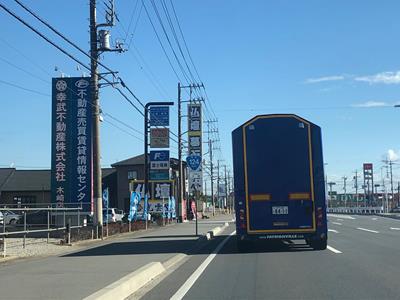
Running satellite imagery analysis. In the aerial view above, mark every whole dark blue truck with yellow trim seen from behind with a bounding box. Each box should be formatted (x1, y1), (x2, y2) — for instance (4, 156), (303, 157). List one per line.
(232, 114), (328, 250)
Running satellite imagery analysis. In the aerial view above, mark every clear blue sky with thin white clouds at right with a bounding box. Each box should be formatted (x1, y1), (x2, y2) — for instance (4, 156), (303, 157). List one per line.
(0, 0), (400, 193)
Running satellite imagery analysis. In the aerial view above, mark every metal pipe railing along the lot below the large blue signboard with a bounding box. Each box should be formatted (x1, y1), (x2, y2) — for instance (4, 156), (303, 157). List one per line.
(0, 207), (87, 257)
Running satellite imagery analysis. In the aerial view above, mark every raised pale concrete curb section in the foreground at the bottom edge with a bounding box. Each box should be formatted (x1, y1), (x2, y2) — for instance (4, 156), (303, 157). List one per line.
(84, 262), (166, 300)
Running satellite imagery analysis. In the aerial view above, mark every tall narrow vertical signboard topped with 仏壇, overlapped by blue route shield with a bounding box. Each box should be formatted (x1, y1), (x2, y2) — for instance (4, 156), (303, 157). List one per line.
(187, 104), (203, 194)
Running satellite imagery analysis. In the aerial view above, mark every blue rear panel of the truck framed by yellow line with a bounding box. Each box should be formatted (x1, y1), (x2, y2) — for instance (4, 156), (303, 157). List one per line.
(243, 115), (315, 233)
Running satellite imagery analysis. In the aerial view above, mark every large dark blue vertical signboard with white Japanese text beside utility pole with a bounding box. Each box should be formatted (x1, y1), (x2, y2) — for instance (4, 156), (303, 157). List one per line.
(51, 77), (92, 211)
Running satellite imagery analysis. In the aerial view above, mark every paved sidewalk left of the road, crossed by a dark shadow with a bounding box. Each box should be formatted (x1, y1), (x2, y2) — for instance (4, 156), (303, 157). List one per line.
(0, 215), (232, 299)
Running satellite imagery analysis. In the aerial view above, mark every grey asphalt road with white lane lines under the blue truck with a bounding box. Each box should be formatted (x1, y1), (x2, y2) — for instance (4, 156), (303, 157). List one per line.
(141, 215), (400, 299)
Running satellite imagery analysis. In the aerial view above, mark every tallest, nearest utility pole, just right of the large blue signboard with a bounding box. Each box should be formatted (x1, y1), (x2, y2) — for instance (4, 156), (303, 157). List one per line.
(89, 0), (103, 238)
